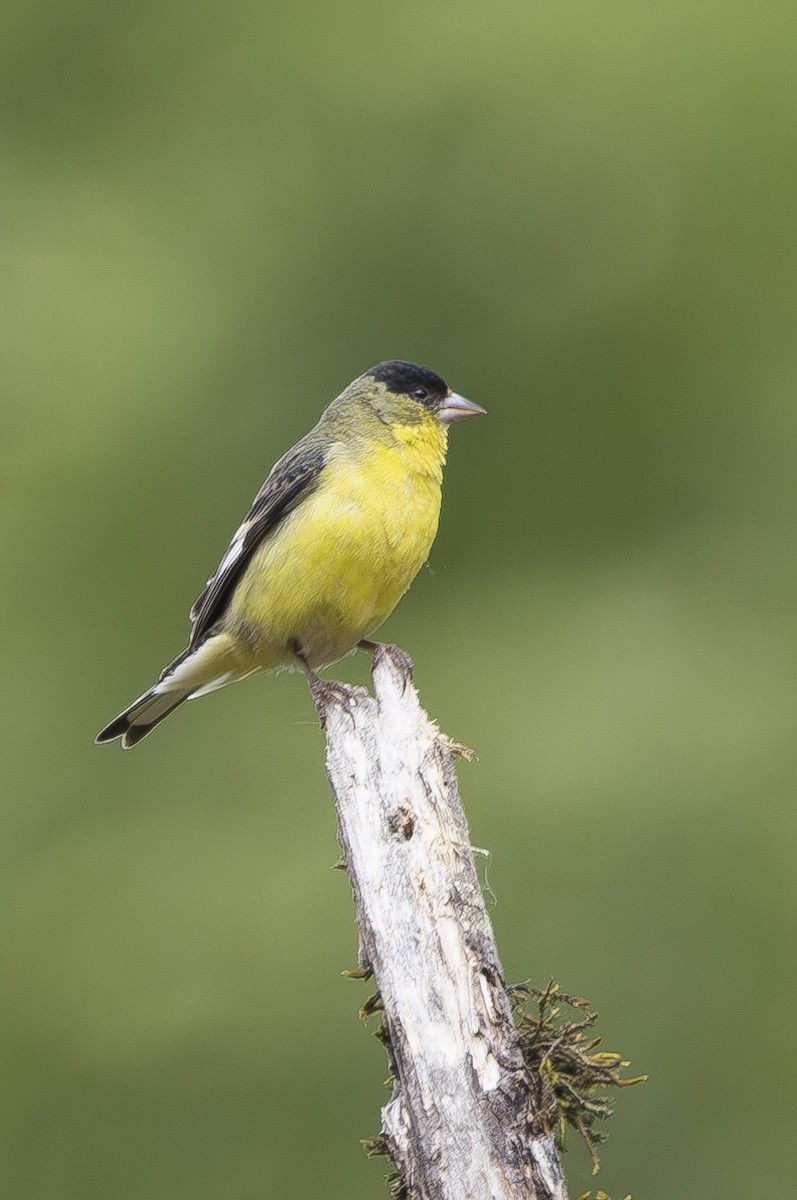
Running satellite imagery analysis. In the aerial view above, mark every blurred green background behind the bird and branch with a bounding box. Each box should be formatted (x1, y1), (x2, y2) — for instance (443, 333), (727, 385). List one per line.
(0, 0), (797, 1200)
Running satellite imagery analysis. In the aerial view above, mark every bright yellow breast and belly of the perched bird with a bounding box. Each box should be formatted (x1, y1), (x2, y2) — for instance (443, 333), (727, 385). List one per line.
(226, 421), (445, 670)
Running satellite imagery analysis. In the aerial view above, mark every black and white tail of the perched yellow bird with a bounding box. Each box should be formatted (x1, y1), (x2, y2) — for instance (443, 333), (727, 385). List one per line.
(94, 635), (245, 750)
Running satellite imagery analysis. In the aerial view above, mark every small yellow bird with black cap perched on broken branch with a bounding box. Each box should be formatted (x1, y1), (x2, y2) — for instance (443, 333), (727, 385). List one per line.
(95, 359), (485, 750)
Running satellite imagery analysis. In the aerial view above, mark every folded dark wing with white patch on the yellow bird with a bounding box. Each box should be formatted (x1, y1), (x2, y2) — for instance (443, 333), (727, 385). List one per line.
(188, 439), (329, 646)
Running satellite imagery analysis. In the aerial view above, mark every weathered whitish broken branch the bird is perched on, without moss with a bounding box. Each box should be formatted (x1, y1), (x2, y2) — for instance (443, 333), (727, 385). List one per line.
(313, 647), (567, 1200)
